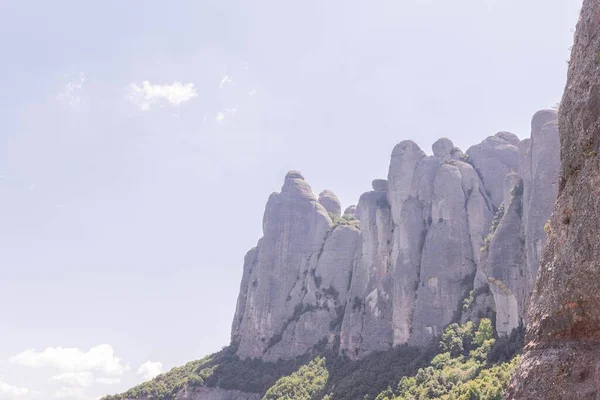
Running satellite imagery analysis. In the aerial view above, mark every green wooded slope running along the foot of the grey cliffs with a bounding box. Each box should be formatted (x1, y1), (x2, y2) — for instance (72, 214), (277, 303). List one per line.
(105, 318), (525, 400)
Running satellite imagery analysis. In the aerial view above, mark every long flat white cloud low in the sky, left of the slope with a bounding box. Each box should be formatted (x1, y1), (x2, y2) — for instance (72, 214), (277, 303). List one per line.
(10, 344), (129, 376)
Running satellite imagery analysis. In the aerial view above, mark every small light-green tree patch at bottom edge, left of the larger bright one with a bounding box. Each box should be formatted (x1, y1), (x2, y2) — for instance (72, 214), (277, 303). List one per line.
(263, 357), (329, 400)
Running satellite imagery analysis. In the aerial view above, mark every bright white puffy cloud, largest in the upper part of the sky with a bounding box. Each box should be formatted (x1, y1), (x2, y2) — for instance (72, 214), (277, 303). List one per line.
(125, 81), (198, 111)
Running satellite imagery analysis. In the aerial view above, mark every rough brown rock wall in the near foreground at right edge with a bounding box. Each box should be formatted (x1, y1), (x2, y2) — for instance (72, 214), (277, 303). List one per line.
(507, 0), (600, 399)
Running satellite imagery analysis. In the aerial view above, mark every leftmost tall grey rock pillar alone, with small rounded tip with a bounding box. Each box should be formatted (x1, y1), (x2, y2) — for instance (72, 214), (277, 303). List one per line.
(232, 172), (332, 358)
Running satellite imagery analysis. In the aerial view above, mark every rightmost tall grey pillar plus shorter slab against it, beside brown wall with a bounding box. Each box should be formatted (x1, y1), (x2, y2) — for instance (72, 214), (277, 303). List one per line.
(482, 110), (560, 334)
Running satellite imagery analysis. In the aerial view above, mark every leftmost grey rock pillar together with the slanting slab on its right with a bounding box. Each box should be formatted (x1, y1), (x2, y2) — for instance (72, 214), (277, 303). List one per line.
(232, 171), (359, 361)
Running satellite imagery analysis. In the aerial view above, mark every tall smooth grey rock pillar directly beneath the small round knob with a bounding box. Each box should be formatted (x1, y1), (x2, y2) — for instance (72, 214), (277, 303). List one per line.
(409, 161), (485, 345)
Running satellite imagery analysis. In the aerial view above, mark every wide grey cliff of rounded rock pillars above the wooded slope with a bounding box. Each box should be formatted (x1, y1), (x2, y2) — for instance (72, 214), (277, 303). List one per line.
(232, 110), (559, 361)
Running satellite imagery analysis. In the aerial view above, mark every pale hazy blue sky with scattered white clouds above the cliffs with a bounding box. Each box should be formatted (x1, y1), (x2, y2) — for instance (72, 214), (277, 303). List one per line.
(0, 0), (581, 400)
